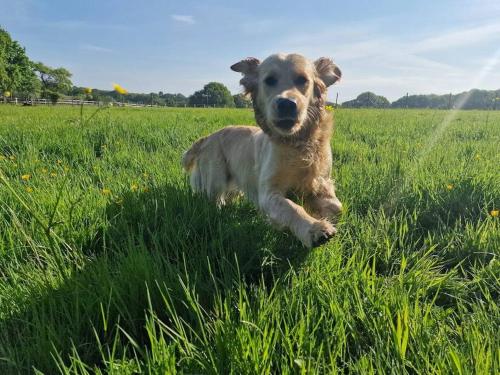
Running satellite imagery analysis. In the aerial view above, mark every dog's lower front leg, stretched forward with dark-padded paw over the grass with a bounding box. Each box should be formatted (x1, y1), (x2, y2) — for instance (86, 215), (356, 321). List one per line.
(259, 191), (337, 248)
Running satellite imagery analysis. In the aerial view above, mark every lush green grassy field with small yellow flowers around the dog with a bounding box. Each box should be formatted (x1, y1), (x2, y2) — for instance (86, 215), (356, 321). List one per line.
(0, 106), (500, 374)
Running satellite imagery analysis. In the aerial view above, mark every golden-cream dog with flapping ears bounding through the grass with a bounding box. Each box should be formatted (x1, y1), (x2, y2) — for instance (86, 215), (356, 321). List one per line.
(182, 54), (342, 248)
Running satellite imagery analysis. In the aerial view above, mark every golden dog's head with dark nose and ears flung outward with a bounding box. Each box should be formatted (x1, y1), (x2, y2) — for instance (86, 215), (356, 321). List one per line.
(231, 54), (341, 138)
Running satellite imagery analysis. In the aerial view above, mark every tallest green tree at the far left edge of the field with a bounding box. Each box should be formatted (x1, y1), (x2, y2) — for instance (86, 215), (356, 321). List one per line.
(0, 28), (40, 96)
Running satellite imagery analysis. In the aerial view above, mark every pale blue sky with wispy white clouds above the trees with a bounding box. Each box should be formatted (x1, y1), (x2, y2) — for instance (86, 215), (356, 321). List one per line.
(0, 0), (500, 101)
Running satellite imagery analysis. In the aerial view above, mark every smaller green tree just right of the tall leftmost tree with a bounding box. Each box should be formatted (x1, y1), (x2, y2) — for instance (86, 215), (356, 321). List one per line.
(33, 62), (73, 101)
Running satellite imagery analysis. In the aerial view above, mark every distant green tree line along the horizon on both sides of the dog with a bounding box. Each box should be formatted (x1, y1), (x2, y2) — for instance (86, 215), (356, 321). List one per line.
(0, 27), (500, 109)
